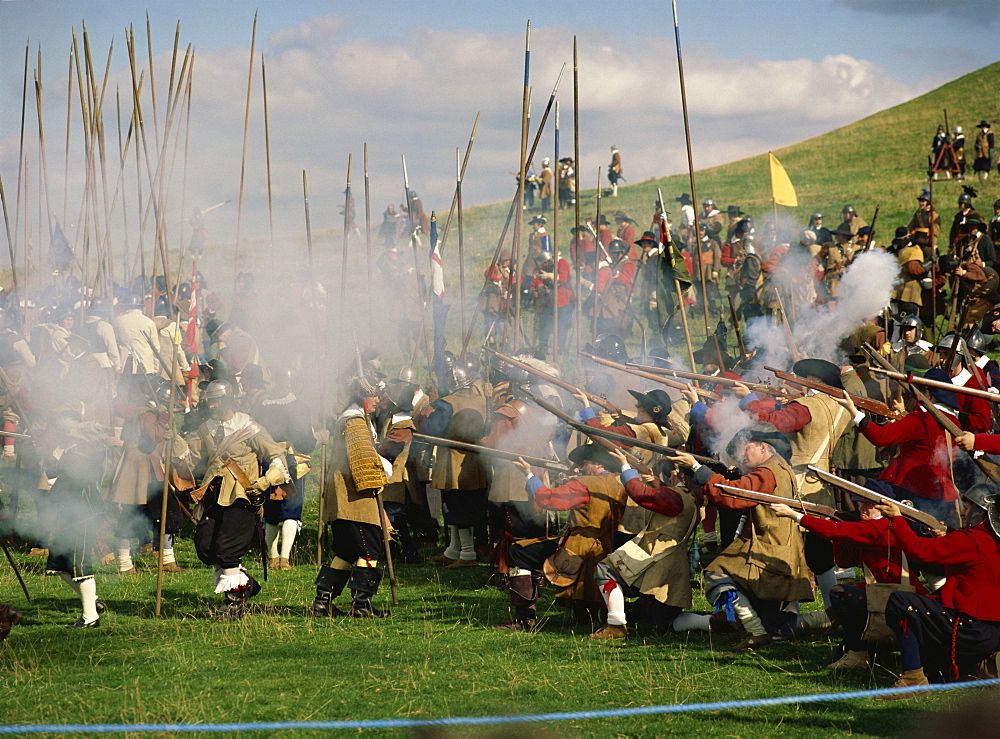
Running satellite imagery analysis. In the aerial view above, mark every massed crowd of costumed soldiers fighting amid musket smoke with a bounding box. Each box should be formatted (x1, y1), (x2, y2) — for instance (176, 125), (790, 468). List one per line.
(0, 181), (1000, 704)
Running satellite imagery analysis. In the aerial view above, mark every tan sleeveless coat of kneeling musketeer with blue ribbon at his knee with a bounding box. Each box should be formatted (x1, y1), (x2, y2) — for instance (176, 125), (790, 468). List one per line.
(705, 456), (814, 601)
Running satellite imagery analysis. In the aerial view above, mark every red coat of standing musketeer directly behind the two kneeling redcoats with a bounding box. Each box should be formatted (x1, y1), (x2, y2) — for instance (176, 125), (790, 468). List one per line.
(861, 408), (958, 501)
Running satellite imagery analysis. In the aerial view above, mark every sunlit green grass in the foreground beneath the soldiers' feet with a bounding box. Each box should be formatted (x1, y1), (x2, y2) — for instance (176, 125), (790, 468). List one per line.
(0, 482), (992, 737)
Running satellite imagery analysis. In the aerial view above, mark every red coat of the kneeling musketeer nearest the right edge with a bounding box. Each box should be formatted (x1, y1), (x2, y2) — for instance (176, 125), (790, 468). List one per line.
(892, 517), (1000, 621)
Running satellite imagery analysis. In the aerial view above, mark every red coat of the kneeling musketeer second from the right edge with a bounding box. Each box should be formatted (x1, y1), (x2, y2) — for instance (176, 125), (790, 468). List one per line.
(799, 515), (926, 595)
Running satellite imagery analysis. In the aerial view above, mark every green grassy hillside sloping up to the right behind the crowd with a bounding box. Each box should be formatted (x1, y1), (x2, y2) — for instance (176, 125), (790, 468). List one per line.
(466, 57), (1000, 251)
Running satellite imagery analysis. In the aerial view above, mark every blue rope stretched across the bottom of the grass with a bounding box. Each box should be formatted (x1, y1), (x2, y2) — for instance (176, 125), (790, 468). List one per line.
(7, 678), (1000, 734)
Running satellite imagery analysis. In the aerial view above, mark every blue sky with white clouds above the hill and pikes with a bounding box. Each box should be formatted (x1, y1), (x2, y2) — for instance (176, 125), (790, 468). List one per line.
(0, 0), (1000, 251)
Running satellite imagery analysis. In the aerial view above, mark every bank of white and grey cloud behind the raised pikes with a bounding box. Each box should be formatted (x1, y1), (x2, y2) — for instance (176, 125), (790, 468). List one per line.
(0, 16), (922, 254)
